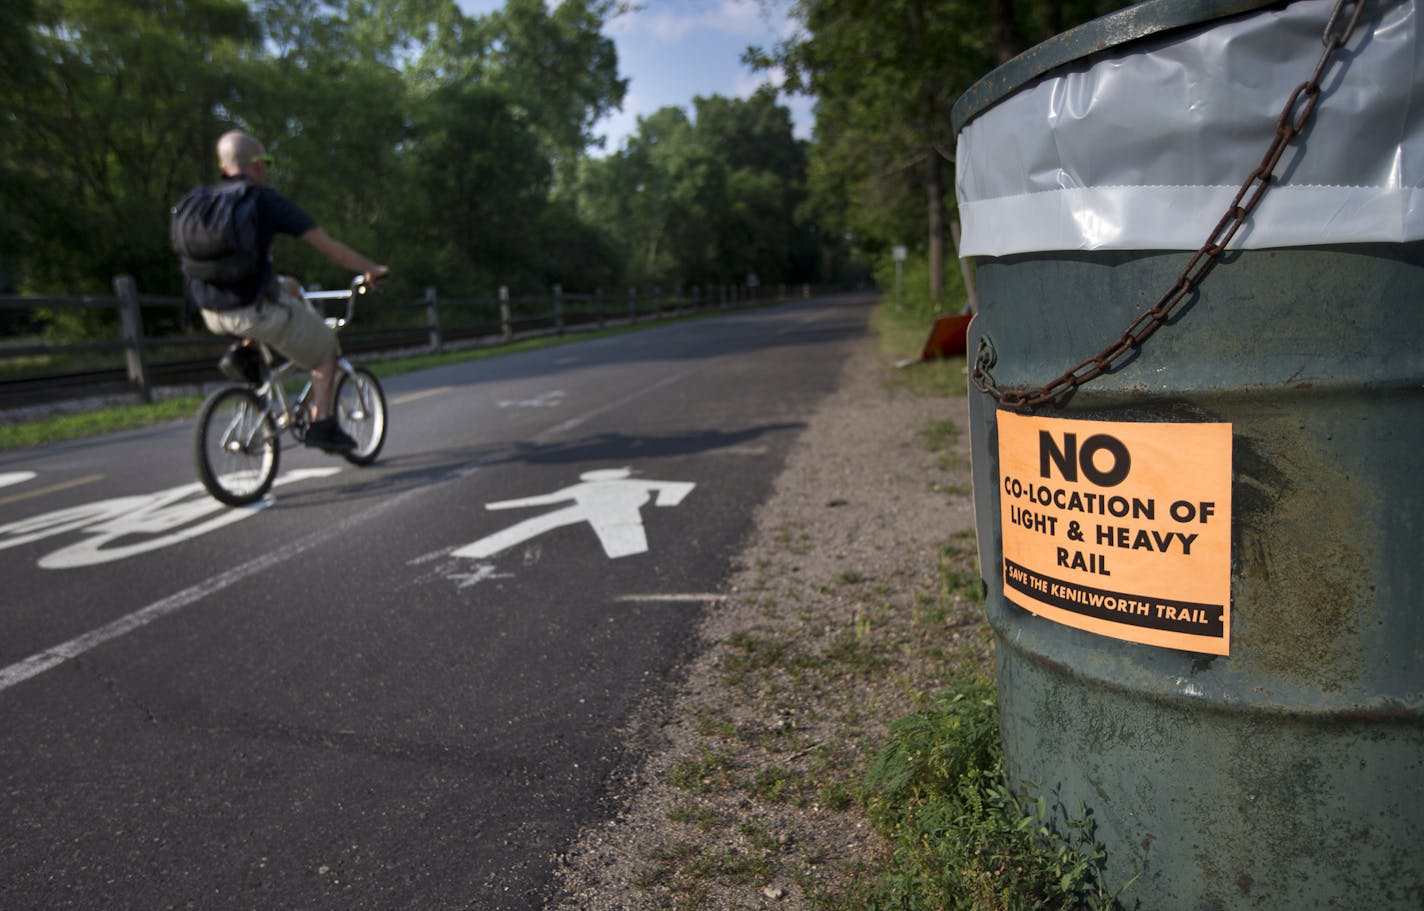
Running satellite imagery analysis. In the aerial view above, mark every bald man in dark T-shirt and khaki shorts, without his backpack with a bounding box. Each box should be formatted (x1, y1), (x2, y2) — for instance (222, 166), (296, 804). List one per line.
(184, 130), (390, 453)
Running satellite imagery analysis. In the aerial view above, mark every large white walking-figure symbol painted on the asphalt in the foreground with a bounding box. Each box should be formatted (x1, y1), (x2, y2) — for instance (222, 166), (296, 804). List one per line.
(453, 468), (696, 559)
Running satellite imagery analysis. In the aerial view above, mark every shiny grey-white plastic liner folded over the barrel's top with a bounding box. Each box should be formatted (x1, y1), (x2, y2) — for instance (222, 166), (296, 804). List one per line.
(956, 0), (1424, 256)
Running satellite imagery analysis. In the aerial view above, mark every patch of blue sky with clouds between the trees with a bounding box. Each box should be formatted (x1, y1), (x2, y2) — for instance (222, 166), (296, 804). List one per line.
(459, 0), (815, 152)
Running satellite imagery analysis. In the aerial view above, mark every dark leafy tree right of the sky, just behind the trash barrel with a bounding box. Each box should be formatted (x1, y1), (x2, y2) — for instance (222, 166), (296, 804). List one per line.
(746, 0), (1124, 306)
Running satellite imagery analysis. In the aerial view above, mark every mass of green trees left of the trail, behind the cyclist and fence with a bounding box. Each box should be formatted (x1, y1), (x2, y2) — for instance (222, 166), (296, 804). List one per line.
(0, 0), (848, 300)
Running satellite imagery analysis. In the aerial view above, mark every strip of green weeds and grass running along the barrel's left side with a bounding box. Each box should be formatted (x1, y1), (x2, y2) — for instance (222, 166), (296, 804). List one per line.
(822, 278), (1115, 911)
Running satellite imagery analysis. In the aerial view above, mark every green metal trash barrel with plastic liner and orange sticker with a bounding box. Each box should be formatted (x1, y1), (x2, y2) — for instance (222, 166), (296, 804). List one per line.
(953, 0), (1424, 911)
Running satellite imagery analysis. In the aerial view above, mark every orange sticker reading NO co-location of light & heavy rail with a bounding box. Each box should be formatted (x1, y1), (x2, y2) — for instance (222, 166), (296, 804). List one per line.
(998, 411), (1232, 655)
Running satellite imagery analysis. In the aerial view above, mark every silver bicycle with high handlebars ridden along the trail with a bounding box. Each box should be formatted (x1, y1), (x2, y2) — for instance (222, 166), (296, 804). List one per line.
(194, 276), (386, 507)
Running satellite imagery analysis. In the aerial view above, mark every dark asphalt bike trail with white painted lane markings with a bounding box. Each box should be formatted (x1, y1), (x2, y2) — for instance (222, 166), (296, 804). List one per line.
(0, 296), (869, 908)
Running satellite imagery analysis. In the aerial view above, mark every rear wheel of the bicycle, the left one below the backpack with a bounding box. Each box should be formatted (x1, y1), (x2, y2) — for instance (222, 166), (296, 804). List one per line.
(194, 386), (282, 507)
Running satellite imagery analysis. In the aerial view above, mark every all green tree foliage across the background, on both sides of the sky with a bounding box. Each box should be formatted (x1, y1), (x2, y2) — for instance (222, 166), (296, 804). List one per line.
(0, 0), (1121, 327)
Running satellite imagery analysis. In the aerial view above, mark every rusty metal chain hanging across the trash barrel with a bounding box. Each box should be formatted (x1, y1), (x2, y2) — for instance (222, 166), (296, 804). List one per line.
(971, 0), (1366, 411)
